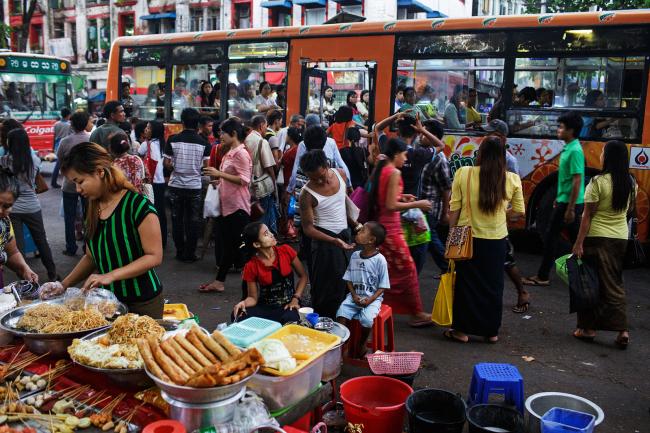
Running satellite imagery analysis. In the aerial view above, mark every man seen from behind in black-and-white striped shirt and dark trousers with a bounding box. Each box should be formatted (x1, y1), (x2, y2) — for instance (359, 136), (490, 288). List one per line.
(164, 108), (210, 263)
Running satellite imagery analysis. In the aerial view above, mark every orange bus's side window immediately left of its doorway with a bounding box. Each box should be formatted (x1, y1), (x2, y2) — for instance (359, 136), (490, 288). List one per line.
(228, 61), (287, 121)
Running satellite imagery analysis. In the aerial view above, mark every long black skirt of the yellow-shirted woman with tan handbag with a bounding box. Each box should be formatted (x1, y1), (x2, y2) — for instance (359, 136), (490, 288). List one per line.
(452, 238), (506, 337)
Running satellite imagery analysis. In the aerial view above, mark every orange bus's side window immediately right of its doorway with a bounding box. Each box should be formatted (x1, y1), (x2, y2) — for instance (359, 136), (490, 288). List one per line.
(395, 58), (504, 129)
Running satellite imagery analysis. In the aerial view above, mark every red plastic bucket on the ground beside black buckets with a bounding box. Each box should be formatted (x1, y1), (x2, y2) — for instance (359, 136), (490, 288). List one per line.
(341, 376), (413, 433)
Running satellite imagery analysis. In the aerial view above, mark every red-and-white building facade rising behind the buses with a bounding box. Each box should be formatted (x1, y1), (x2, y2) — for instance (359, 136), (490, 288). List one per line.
(3, 0), (470, 93)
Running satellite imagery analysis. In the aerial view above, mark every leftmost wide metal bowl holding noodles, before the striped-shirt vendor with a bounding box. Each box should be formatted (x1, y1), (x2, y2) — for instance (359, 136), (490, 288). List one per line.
(0, 299), (128, 356)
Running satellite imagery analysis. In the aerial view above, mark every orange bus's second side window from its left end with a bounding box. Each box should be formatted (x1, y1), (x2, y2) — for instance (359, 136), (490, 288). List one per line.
(171, 64), (221, 120)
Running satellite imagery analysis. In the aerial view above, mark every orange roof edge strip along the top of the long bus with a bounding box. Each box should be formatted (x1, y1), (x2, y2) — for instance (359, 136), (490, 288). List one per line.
(115, 9), (650, 47)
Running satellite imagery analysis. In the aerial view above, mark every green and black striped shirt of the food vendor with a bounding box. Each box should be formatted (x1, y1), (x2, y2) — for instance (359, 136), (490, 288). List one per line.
(88, 191), (162, 303)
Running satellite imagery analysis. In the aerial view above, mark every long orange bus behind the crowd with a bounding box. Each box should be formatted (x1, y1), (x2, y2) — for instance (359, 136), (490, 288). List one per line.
(107, 10), (650, 240)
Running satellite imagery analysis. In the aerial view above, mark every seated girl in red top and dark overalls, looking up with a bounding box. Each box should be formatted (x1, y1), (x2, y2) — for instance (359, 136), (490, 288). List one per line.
(233, 222), (307, 324)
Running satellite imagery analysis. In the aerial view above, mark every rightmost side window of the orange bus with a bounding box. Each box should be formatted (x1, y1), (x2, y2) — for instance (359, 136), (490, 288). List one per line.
(508, 57), (645, 139)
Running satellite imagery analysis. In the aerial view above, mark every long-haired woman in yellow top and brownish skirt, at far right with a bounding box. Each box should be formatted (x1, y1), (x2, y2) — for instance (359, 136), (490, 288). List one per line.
(573, 140), (636, 349)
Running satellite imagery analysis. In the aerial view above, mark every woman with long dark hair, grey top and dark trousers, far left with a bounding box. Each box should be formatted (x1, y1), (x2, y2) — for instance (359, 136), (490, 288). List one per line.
(0, 128), (57, 280)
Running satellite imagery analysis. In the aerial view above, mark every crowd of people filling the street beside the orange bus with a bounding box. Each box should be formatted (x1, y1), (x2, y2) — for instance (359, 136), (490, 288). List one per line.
(0, 91), (636, 356)
